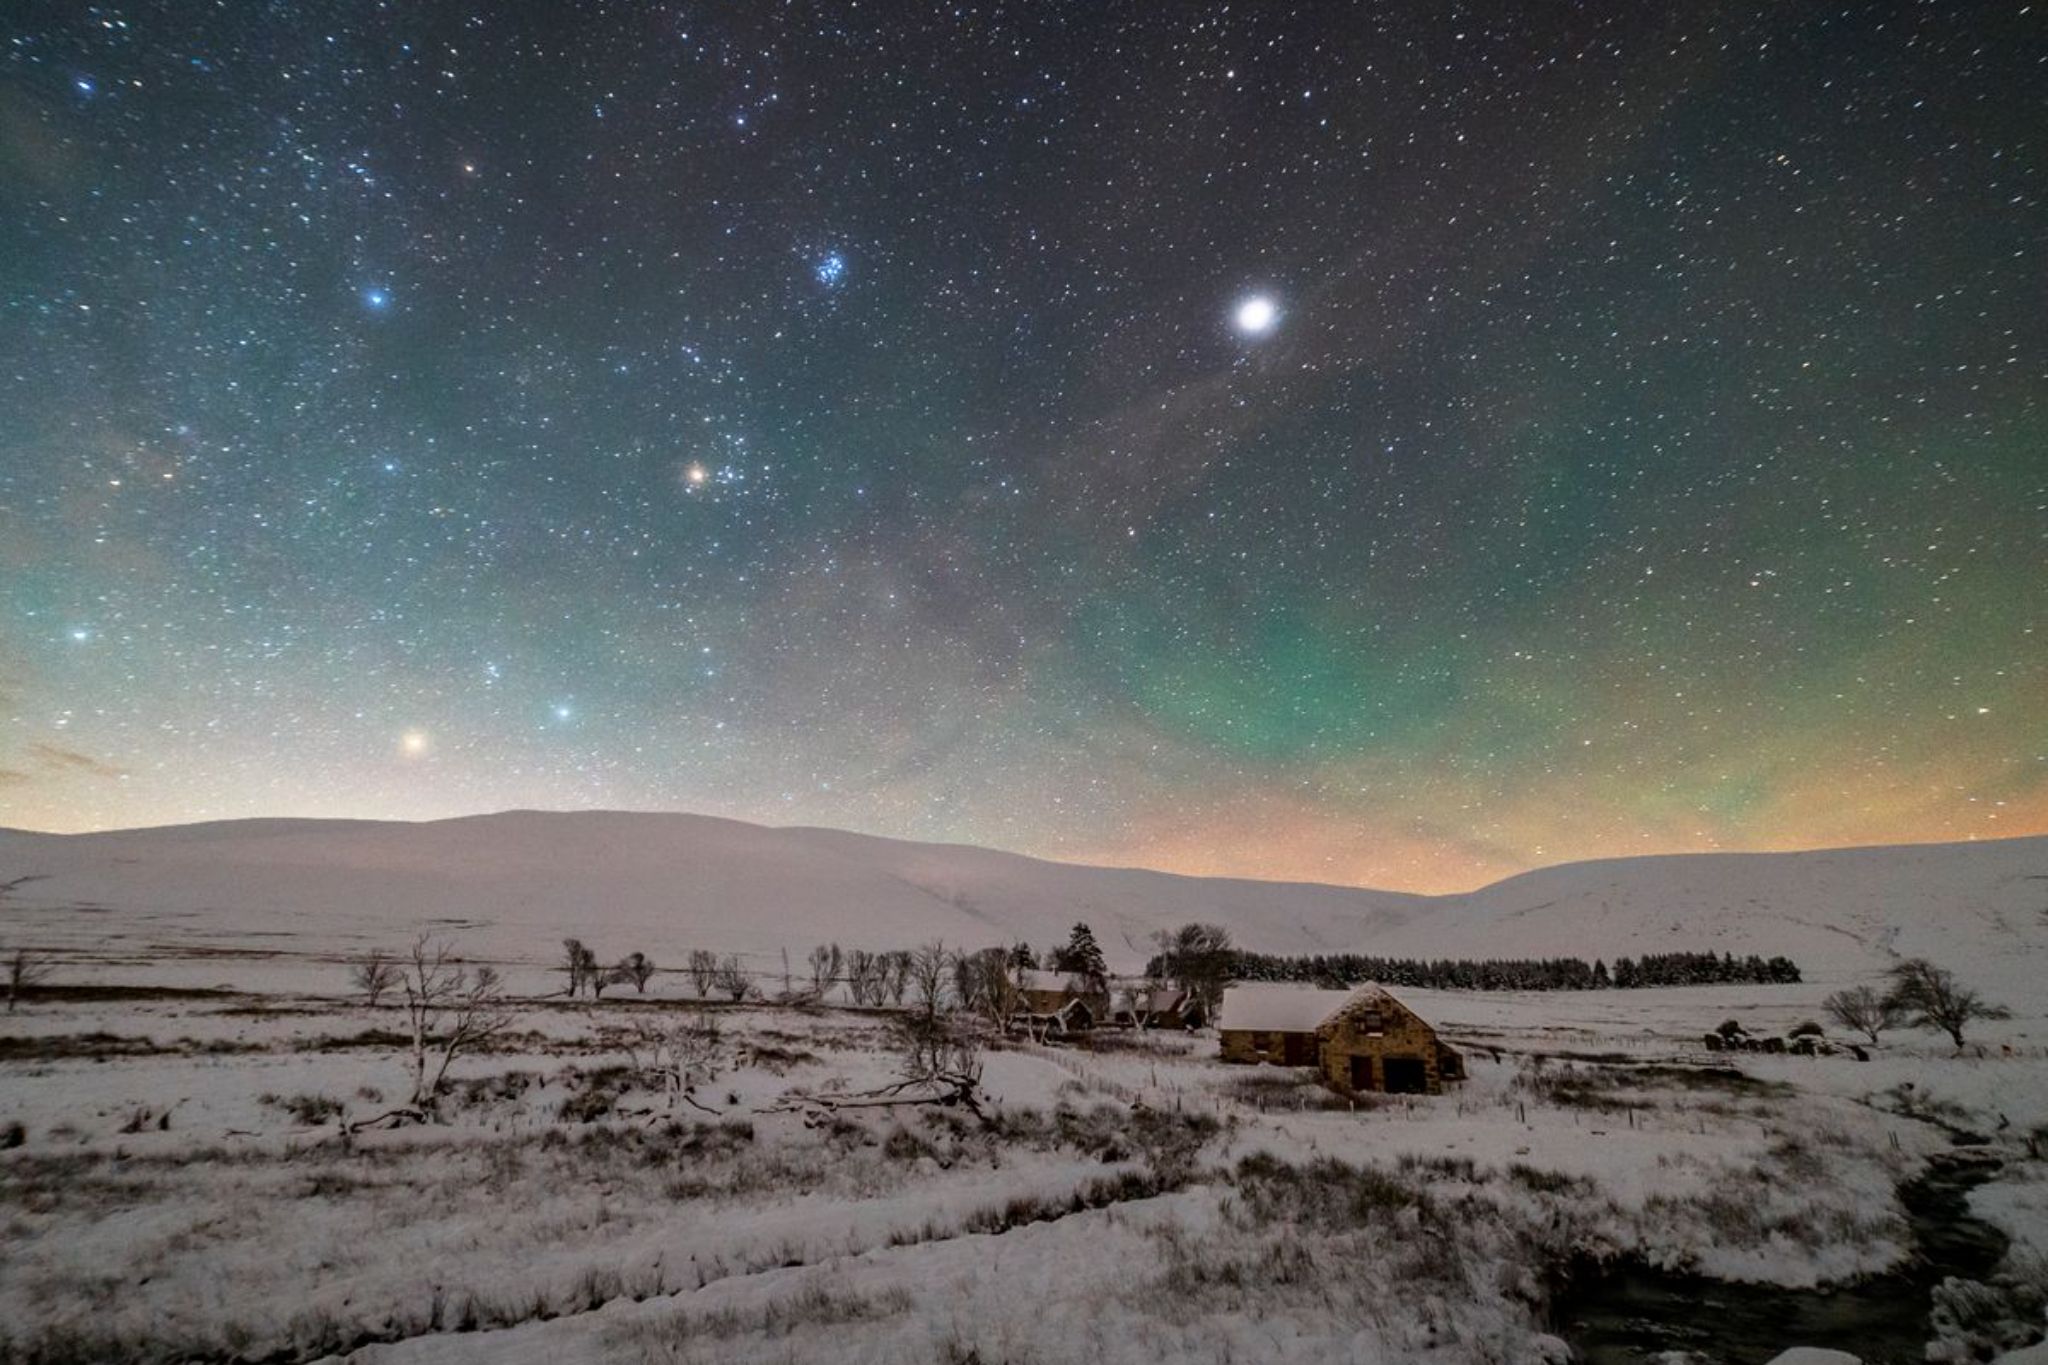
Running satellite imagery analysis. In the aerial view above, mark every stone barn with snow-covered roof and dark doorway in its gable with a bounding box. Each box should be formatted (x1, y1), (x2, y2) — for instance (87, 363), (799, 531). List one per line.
(1219, 984), (1464, 1095)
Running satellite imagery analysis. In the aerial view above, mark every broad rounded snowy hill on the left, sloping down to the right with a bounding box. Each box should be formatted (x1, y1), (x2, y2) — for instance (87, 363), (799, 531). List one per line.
(0, 810), (1430, 964)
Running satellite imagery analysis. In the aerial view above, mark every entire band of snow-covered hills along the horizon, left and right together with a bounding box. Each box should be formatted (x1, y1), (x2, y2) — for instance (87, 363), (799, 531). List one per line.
(0, 810), (2048, 995)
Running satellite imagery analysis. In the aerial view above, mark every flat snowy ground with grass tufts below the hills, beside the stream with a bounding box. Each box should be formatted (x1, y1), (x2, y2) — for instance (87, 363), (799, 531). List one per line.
(0, 962), (2048, 1365)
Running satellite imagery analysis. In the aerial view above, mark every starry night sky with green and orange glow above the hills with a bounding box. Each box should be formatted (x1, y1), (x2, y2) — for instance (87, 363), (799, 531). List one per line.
(0, 0), (2048, 890)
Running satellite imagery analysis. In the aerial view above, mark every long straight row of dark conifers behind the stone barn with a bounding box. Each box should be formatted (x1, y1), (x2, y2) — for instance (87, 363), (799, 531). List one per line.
(1196, 950), (1800, 990)
